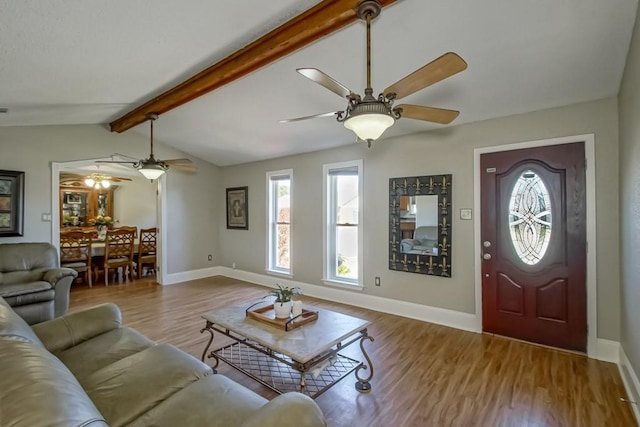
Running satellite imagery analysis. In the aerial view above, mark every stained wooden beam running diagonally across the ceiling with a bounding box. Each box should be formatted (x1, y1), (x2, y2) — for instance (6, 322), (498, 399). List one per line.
(109, 0), (397, 133)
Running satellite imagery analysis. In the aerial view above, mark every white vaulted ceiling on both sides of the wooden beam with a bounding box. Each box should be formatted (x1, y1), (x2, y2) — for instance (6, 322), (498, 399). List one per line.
(0, 0), (638, 166)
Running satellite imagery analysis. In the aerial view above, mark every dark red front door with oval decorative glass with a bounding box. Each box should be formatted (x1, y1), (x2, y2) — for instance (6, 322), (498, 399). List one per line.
(480, 143), (587, 351)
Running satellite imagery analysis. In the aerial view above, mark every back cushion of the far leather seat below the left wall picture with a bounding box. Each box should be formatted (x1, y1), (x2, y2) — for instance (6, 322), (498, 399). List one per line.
(0, 243), (59, 285)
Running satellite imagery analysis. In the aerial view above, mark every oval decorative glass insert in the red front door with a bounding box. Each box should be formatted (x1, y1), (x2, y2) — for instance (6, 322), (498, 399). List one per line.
(508, 170), (551, 265)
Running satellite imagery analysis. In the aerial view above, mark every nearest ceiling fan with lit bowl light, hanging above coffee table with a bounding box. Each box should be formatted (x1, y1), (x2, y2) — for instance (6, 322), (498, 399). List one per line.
(280, 0), (467, 147)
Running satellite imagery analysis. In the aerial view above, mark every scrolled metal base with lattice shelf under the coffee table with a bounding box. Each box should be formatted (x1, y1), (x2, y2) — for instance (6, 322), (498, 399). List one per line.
(200, 321), (373, 398)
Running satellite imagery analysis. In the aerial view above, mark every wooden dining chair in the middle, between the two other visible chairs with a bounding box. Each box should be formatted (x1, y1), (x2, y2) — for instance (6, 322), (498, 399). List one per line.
(103, 227), (138, 286)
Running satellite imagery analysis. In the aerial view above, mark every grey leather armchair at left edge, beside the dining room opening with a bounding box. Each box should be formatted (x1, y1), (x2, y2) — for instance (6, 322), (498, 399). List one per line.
(0, 243), (78, 324)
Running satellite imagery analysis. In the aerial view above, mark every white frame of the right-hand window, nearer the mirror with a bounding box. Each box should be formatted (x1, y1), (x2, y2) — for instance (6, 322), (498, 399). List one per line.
(322, 159), (364, 289)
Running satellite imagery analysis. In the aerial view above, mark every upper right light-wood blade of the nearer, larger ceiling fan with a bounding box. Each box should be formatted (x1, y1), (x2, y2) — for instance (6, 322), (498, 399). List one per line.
(383, 52), (467, 99)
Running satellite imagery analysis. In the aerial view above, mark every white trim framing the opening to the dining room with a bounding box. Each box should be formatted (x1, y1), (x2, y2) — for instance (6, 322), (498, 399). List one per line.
(51, 157), (167, 285)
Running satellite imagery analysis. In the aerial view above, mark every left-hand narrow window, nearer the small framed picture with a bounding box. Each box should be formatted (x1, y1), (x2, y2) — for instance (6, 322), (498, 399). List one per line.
(267, 169), (293, 275)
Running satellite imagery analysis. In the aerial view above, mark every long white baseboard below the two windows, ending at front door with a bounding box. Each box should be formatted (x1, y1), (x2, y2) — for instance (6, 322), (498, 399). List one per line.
(218, 267), (478, 332)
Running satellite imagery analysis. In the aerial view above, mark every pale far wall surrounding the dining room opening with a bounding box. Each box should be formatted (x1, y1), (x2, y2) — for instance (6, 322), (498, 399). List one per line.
(0, 125), (224, 273)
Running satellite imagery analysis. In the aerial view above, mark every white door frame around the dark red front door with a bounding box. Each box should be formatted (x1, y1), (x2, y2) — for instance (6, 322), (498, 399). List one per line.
(473, 133), (598, 358)
